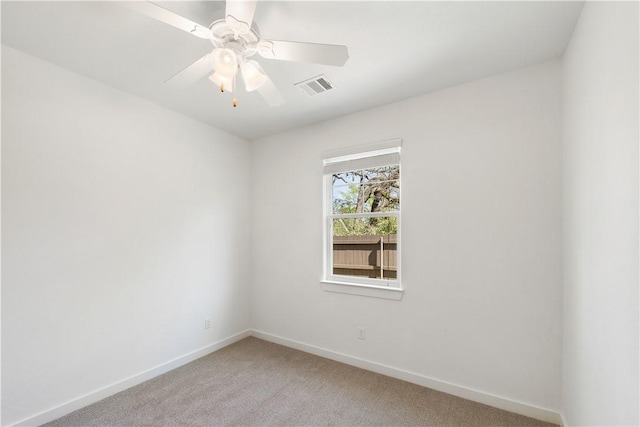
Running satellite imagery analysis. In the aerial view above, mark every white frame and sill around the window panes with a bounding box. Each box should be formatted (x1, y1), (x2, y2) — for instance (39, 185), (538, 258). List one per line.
(321, 139), (403, 300)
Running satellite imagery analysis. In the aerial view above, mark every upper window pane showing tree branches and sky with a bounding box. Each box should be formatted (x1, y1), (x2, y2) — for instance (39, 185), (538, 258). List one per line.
(332, 165), (400, 213)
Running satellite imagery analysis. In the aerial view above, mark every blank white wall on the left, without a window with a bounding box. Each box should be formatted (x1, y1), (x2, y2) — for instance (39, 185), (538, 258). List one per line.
(2, 47), (250, 425)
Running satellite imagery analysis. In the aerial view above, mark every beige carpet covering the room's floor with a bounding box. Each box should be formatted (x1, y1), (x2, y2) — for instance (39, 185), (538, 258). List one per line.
(46, 337), (552, 426)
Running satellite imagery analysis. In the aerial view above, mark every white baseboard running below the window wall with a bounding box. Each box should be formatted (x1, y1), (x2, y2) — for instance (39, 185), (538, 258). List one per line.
(251, 330), (564, 424)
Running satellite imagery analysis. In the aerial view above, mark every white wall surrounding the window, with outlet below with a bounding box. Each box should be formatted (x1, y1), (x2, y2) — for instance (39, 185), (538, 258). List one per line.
(252, 61), (562, 418)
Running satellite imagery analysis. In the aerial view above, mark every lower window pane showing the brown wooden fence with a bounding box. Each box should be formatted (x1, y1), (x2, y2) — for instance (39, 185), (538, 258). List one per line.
(332, 217), (398, 280)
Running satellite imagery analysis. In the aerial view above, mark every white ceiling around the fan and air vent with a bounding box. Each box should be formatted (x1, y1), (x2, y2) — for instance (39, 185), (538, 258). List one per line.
(1, 1), (583, 139)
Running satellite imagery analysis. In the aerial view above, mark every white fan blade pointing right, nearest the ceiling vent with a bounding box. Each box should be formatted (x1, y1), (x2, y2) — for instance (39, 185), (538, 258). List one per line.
(258, 40), (349, 66)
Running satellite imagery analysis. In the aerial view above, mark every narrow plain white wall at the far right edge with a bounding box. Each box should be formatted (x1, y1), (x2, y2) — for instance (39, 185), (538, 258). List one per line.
(563, 2), (640, 426)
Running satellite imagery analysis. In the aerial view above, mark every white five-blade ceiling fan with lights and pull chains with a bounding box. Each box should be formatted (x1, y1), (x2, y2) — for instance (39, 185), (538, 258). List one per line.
(127, 0), (349, 107)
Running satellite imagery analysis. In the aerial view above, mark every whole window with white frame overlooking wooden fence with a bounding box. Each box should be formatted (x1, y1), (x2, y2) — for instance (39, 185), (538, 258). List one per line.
(324, 140), (400, 293)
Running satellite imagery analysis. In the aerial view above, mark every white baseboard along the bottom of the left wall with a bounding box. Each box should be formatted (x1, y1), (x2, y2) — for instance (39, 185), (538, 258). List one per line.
(13, 330), (251, 426)
